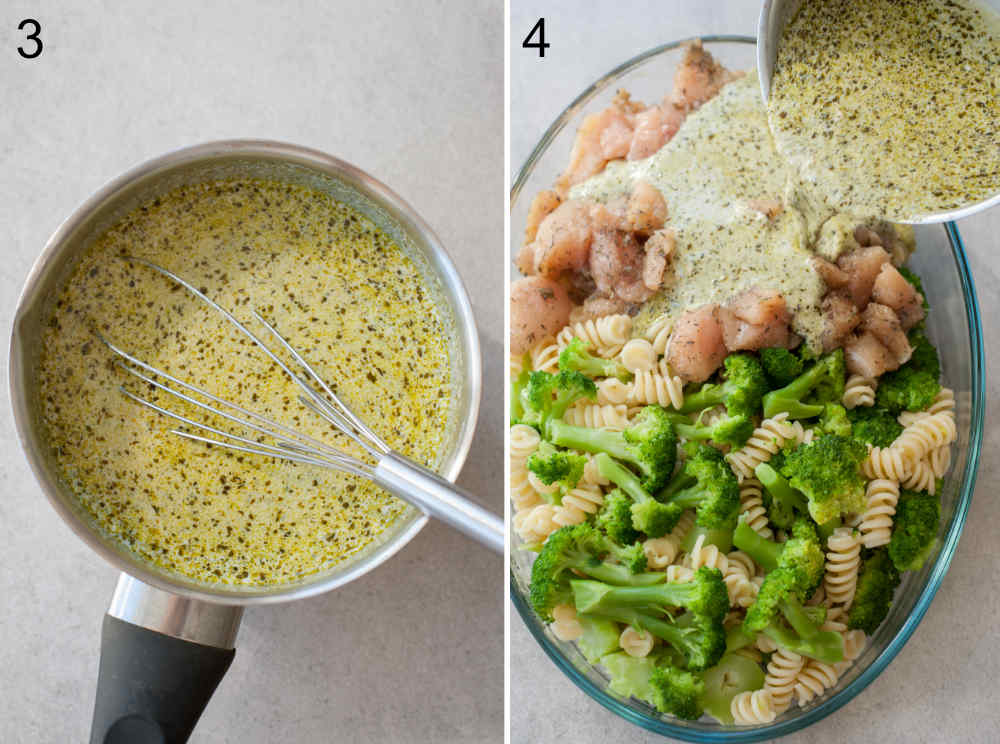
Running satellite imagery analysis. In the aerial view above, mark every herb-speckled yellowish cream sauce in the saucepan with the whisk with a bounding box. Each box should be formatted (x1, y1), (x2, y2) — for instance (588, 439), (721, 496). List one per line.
(40, 179), (452, 585)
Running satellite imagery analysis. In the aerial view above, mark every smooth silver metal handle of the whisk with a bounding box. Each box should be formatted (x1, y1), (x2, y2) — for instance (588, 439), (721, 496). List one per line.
(375, 452), (504, 553)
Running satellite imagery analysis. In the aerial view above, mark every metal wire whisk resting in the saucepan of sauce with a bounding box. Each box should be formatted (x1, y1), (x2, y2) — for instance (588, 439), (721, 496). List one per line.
(100, 256), (504, 553)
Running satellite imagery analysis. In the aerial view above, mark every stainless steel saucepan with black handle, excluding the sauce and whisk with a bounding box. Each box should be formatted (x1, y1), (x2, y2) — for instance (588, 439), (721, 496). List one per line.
(10, 140), (481, 744)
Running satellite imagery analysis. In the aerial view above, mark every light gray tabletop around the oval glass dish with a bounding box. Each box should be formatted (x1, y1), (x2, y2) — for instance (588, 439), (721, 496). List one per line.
(510, 0), (1000, 744)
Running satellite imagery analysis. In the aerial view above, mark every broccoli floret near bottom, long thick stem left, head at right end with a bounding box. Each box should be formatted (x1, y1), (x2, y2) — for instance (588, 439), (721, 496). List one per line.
(570, 566), (729, 671)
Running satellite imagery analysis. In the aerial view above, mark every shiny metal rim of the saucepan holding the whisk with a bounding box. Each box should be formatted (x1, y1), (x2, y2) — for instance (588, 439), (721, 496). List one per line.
(8, 139), (482, 606)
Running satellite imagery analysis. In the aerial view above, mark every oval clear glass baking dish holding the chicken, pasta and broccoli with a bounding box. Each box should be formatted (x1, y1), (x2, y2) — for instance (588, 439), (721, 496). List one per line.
(511, 36), (985, 742)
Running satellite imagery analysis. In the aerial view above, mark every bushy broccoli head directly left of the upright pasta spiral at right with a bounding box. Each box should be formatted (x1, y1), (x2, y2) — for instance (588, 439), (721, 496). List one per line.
(781, 434), (868, 524)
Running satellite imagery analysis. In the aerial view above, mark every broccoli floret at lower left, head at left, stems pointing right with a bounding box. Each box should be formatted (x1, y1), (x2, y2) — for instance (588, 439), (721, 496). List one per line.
(530, 523), (665, 620)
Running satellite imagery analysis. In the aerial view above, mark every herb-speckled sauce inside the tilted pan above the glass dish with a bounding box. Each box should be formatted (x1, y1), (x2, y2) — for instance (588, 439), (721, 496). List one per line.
(768, 0), (1000, 222)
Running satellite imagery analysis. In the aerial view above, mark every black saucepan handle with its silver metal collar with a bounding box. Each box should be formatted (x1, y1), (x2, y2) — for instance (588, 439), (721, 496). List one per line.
(90, 574), (243, 744)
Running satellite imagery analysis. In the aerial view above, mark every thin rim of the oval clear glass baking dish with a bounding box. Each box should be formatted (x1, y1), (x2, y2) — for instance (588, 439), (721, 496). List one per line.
(510, 34), (986, 742)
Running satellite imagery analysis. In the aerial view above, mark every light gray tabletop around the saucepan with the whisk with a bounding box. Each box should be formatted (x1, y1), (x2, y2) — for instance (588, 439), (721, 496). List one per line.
(0, 0), (504, 744)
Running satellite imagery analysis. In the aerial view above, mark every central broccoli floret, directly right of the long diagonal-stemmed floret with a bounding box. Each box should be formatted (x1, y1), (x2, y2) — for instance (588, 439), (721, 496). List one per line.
(659, 445), (740, 551)
